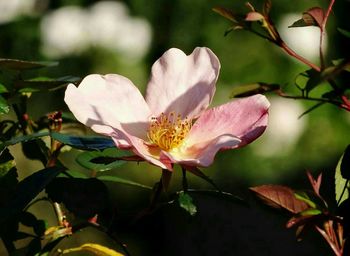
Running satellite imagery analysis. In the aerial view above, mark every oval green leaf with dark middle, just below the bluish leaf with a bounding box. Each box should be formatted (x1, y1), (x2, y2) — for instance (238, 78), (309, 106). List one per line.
(75, 147), (130, 172)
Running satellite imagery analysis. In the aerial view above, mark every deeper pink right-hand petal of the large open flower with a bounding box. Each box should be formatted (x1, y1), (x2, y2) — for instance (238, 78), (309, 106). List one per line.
(170, 95), (270, 166)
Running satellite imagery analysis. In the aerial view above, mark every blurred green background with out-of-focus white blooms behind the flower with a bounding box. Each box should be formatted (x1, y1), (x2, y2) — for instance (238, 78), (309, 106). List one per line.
(0, 0), (350, 255)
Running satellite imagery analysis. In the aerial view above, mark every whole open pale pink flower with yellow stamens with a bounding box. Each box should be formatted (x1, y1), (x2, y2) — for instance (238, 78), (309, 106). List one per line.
(65, 47), (270, 170)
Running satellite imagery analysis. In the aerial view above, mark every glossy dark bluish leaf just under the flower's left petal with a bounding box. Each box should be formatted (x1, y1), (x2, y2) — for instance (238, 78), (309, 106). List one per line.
(51, 132), (115, 150)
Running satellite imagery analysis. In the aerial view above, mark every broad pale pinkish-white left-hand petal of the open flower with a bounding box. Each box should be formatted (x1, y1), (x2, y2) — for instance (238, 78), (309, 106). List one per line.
(65, 75), (150, 142)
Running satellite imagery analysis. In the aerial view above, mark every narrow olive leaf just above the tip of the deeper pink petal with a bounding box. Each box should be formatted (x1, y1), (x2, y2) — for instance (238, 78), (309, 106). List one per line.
(230, 83), (280, 98)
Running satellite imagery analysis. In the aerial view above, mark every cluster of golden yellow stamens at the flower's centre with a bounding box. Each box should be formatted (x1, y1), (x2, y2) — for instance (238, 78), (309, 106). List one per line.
(147, 112), (192, 151)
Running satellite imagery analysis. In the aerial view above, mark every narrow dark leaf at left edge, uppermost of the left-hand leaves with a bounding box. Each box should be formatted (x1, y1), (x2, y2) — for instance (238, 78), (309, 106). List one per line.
(0, 58), (58, 70)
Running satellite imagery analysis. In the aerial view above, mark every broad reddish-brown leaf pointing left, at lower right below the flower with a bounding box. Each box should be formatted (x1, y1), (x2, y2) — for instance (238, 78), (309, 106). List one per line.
(250, 185), (309, 213)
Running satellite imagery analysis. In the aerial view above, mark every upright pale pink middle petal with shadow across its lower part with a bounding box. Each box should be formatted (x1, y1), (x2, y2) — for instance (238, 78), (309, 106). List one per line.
(146, 47), (220, 118)
